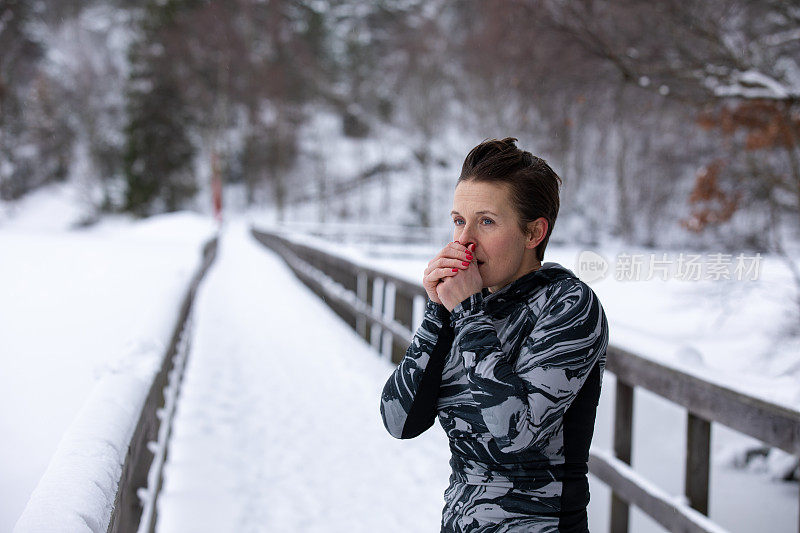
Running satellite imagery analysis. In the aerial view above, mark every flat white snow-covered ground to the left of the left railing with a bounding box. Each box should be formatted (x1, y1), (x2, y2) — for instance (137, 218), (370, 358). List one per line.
(0, 186), (215, 531)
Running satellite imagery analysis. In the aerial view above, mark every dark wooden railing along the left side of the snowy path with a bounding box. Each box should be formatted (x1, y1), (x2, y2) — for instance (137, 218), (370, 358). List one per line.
(107, 237), (217, 533)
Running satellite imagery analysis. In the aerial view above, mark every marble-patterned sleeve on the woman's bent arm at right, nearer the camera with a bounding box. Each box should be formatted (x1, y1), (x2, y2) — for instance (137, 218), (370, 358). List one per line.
(452, 279), (608, 452)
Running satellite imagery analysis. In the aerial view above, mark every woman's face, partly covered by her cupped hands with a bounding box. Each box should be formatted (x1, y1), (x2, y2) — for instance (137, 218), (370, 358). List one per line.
(451, 180), (541, 292)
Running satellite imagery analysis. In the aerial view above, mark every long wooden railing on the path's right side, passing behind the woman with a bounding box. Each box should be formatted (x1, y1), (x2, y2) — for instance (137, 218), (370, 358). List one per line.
(252, 228), (800, 533)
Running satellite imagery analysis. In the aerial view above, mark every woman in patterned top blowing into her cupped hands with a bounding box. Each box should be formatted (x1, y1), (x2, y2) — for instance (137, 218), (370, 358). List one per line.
(381, 138), (608, 532)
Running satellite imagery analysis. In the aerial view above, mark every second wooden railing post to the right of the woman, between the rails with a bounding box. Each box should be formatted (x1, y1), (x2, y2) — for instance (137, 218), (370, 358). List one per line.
(684, 411), (711, 516)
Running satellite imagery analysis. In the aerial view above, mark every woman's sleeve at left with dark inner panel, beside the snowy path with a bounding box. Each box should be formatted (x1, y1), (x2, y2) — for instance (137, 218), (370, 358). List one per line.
(381, 300), (453, 439)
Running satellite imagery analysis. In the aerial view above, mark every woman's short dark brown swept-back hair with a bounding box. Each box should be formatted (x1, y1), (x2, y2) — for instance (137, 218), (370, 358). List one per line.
(456, 137), (561, 261)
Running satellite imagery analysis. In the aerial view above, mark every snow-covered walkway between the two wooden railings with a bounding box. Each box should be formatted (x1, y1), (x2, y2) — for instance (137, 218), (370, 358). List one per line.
(157, 219), (450, 533)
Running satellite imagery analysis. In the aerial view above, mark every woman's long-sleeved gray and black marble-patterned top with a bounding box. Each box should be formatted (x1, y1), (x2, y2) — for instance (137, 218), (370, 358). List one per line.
(380, 262), (608, 531)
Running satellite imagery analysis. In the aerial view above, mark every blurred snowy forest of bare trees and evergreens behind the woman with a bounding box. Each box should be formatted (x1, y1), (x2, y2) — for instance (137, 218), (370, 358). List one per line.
(0, 0), (800, 266)
